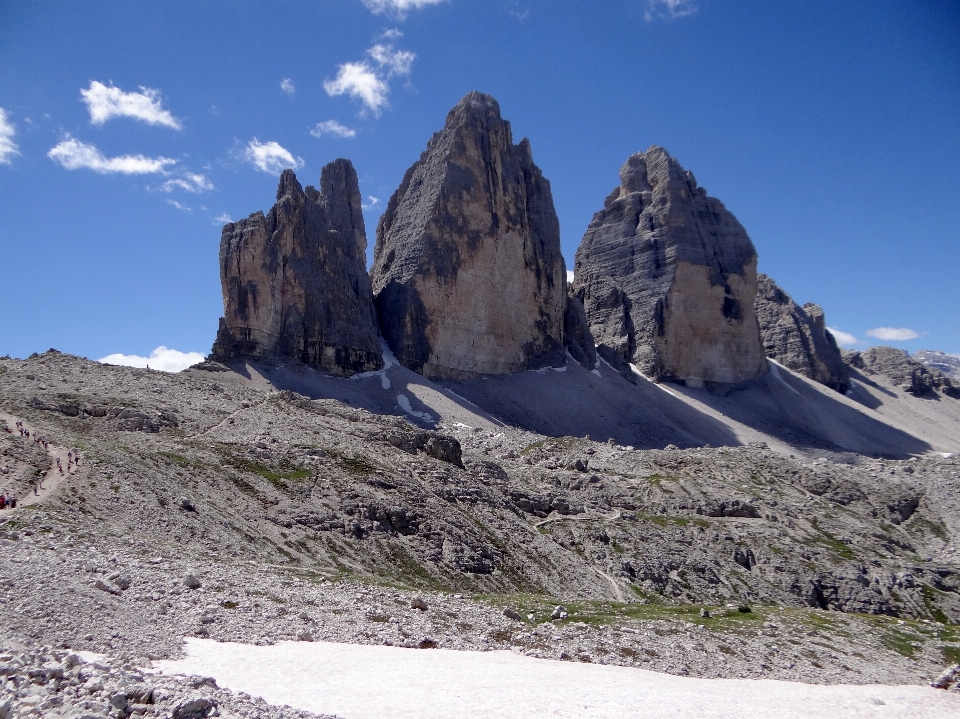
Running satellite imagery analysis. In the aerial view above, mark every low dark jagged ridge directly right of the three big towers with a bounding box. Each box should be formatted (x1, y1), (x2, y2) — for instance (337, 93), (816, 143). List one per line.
(754, 274), (850, 394)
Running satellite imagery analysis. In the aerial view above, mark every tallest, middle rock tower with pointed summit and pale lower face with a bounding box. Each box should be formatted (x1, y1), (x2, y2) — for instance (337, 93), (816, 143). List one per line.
(371, 92), (567, 379)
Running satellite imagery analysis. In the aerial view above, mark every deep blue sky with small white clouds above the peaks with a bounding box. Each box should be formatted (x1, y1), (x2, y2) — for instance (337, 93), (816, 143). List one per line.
(0, 0), (960, 368)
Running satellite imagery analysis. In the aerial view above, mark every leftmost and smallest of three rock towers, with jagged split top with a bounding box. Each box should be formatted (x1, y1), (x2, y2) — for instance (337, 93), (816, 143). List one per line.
(211, 160), (383, 375)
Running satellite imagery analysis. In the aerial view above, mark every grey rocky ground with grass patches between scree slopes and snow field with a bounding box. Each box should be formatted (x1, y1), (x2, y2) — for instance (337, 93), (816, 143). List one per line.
(0, 352), (960, 717)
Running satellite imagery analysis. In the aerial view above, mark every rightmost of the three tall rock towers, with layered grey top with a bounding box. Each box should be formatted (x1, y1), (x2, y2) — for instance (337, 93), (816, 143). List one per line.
(574, 146), (766, 386)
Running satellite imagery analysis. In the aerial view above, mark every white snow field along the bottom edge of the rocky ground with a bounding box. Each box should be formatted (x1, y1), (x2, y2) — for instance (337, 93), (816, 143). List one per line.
(153, 638), (960, 719)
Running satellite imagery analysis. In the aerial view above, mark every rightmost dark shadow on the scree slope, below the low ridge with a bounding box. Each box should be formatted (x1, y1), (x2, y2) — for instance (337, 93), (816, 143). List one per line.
(670, 362), (932, 458)
